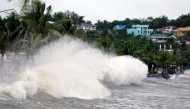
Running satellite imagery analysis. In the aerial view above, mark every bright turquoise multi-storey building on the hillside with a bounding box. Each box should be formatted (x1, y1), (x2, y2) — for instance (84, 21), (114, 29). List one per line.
(127, 25), (153, 36)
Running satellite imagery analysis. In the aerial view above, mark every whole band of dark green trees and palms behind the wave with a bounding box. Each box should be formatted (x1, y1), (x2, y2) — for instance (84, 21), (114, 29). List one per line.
(0, 0), (190, 72)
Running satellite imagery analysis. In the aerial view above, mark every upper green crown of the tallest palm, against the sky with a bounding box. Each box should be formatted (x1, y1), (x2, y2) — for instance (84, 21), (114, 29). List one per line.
(22, 0), (52, 36)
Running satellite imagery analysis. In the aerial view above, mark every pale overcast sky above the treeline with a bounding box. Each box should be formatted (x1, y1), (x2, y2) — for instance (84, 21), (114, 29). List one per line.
(0, 0), (190, 23)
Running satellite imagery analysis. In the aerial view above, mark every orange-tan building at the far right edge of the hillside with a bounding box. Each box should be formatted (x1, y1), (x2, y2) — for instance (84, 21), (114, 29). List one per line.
(173, 26), (190, 37)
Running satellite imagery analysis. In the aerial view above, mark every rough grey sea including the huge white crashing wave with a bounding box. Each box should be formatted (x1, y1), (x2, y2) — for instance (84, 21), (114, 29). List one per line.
(0, 37), (190, 109)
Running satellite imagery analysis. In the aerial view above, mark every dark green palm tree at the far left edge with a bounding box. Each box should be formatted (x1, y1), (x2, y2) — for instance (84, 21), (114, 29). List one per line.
(0, 12), (25, 61)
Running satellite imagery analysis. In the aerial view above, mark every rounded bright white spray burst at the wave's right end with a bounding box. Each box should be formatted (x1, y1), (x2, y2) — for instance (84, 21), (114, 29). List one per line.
(104, 56), (148, 85)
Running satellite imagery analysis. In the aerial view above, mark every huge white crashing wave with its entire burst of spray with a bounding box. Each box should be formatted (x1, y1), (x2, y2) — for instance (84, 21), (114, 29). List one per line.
(0, 37), (148, 99)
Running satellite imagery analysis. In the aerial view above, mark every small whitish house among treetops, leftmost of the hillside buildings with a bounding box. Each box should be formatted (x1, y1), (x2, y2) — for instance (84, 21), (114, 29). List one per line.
(77, 23), (96, 31)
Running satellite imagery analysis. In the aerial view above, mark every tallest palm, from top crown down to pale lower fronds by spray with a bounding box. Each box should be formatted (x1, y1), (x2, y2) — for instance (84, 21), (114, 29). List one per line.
(22, 0), (62, 59)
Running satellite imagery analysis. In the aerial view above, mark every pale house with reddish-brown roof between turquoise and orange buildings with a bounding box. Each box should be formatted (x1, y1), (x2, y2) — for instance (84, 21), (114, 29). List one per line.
(155, 26), (177, 34)
